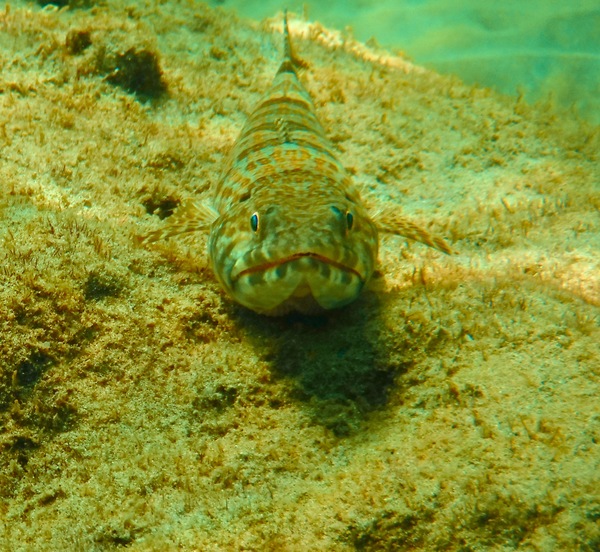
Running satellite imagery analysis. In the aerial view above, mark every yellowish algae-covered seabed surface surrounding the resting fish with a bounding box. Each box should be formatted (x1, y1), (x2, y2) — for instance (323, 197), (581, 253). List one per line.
(0, 1), (600, 552)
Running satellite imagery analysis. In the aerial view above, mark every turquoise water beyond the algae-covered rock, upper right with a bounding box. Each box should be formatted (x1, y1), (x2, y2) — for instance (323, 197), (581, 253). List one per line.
(218, 0), (600, 123)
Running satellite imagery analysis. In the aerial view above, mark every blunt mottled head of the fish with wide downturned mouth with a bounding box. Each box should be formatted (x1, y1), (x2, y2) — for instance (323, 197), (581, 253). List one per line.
(209, 194), (378, 315)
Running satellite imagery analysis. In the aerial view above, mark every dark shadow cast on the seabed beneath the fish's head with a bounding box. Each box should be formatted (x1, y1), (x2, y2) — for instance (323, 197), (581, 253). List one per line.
(240, 293), (408, 437)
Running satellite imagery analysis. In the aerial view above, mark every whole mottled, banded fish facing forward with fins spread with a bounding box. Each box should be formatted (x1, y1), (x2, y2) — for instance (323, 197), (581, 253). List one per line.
(143, 11), (449, 315)
